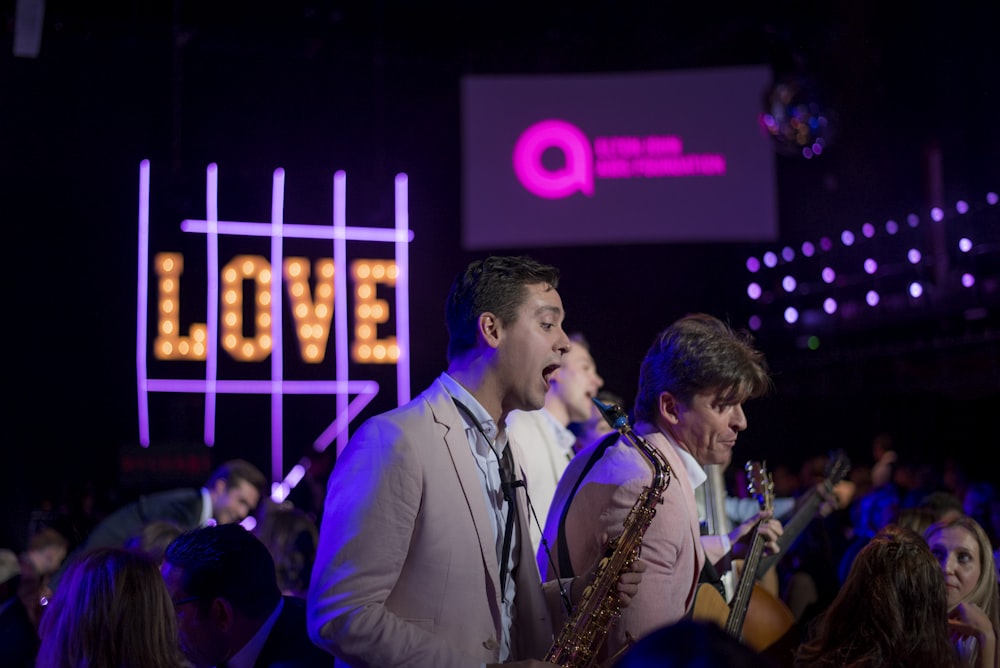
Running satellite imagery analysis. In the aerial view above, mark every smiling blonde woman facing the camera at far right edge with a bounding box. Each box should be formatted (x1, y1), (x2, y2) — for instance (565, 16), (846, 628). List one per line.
(924, 516), (1000, 668)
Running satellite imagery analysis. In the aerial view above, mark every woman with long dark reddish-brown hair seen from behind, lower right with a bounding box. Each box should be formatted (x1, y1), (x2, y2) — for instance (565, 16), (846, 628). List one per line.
(795, 525), (958, 668)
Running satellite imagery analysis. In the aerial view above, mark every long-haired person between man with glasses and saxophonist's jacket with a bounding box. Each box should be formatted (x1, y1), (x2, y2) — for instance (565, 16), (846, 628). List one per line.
(254, 499), (319, 599)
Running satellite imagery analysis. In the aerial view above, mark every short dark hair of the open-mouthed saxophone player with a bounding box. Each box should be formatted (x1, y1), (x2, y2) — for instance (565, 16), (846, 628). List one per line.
(445, 255), (559, 360)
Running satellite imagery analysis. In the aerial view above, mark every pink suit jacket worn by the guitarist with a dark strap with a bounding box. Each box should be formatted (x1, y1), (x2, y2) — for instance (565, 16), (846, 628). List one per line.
(537, 423), (725, 653)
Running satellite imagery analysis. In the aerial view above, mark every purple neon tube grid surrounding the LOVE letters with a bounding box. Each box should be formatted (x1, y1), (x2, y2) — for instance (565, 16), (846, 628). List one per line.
(136, 160), (413, 494)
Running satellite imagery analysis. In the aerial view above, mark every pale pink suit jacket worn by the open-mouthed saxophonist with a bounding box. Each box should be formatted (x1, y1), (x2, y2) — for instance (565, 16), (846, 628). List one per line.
(307, 380), (562, 668)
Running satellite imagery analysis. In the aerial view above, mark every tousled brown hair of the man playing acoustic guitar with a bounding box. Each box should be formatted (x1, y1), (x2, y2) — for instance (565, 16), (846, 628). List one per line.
(635, 313), (771, 422)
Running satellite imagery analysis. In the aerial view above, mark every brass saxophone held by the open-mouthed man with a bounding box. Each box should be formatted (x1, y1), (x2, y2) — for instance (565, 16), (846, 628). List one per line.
(545, 399), (672, 668)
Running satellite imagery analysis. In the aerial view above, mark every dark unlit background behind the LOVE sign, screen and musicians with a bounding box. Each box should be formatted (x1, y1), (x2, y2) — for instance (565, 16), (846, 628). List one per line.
(0, 0), (1000, 547)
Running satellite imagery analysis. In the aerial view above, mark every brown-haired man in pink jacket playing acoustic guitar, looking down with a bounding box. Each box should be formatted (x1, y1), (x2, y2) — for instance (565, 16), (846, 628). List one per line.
(539, 314), (782, 655)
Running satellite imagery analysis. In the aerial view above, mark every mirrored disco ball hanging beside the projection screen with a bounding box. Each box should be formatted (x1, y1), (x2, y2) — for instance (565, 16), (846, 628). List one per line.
(760, 77), (836, 159)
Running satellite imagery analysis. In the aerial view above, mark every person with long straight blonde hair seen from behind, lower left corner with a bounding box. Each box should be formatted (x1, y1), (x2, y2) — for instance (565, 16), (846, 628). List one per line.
(38, 547), (184, 668)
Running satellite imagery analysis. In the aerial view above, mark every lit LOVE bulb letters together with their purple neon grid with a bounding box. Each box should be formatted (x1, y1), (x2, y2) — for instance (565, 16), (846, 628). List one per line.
(136, 160), (413, 500)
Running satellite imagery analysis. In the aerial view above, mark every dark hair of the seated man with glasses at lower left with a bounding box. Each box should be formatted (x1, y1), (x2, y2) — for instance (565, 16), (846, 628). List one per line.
(164, 524), (281, 619)
